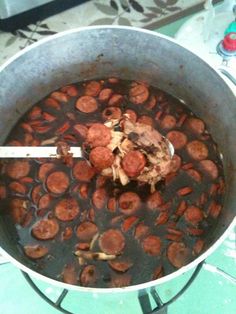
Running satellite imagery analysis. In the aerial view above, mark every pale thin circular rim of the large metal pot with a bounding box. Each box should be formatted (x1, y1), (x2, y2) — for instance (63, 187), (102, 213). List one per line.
(0, 25), (236, 293)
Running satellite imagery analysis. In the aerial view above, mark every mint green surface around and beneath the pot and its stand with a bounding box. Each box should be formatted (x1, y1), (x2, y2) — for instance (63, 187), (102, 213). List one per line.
(0, 8), (236, 314)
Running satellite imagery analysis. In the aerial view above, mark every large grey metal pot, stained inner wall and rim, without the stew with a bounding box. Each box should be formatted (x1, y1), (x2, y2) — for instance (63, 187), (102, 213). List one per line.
(0, 26), (236, 292)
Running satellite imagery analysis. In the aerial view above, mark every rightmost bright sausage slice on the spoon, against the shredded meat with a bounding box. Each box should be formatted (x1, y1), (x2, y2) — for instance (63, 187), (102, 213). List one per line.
(121, 150), (146, 177)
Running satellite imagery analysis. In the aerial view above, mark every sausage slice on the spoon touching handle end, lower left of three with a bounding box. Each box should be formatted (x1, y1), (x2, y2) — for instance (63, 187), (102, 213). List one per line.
(89, 147), (115, 170)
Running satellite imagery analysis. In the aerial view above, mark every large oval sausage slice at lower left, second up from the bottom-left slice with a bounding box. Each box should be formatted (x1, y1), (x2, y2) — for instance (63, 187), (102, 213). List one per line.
(32, 219), (59, 240)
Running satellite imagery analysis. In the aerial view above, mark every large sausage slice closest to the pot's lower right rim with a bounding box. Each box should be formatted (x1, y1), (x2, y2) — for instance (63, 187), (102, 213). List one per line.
(167, 242), (191, 268)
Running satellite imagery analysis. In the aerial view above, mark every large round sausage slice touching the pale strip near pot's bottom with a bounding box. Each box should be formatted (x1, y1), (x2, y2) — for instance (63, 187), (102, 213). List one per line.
(99, 229), (125, 255)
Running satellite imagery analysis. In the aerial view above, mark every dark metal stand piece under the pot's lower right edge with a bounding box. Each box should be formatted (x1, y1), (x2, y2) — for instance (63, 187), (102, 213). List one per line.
(138, 261), (204, 314)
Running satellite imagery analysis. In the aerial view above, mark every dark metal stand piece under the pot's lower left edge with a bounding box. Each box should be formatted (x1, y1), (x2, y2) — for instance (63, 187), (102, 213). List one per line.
(21, 271), (71, 314)
